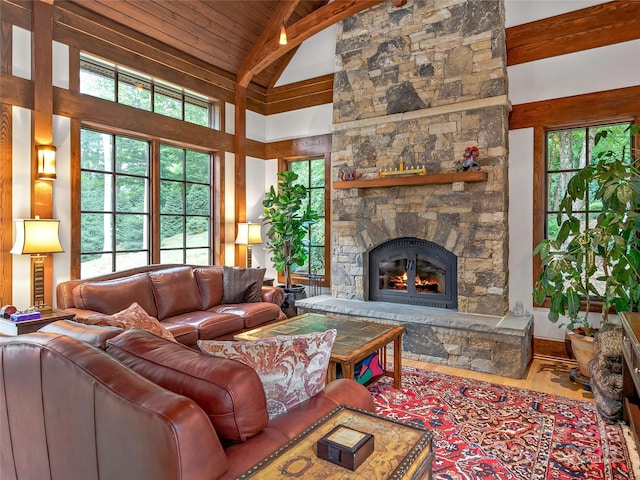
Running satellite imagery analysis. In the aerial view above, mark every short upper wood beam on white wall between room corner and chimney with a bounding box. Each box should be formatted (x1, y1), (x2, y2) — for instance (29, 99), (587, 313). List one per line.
(267, 74), (333, 115)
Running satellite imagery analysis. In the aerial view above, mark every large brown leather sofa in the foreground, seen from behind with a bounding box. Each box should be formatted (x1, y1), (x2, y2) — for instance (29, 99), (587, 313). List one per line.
(0, 321), (374, 480)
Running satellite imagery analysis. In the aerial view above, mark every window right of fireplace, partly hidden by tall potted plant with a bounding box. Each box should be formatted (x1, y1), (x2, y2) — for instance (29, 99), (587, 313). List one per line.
(545, 123), (632, 244)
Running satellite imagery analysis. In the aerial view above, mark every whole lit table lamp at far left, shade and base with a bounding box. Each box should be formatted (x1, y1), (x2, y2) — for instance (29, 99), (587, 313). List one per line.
(11, 216), (64, 311)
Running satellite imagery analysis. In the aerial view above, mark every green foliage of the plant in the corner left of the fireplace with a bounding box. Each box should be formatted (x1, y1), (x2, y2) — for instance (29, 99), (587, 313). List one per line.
(262, 170), (318, 288)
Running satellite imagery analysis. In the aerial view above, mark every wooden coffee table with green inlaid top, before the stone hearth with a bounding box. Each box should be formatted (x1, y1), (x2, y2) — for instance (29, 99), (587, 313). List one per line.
(233, 313), (405, 388)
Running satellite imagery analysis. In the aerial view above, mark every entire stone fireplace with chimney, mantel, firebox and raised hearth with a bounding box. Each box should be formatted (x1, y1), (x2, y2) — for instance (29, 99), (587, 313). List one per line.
(296, 0), (533, 378)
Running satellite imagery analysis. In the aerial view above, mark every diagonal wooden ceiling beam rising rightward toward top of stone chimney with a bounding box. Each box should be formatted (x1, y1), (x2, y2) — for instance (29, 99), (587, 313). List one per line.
(238, 0), (385, 87)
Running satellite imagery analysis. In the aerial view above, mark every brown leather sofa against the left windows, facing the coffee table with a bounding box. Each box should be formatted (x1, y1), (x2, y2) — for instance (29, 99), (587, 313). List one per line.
(56, 265), (286, 346)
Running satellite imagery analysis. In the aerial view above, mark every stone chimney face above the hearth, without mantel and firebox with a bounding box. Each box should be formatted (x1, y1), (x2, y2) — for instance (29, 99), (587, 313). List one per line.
(331, 0), (509, 316)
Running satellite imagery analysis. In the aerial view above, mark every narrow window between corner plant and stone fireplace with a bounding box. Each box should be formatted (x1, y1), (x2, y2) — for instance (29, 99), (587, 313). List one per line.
(288, 157), (329, 284)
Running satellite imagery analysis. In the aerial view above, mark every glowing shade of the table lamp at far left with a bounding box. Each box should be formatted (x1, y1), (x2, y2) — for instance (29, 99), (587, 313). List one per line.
(11, 218), (64, 255)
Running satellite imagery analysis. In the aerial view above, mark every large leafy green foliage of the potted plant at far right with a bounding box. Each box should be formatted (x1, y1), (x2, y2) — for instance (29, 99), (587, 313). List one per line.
(533, 125), (640, 336)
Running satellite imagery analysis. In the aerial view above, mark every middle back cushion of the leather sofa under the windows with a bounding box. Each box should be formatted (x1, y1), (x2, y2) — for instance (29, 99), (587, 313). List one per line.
(149, 266), (202, 320)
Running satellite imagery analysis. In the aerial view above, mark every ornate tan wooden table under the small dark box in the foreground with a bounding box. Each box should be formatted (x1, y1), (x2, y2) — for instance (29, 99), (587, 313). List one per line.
(238, 406), (434, 480)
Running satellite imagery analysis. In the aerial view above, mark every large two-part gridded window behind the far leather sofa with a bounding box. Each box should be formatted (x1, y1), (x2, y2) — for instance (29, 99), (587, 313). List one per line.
(80, 128), (212, 278)
